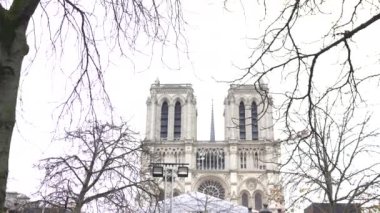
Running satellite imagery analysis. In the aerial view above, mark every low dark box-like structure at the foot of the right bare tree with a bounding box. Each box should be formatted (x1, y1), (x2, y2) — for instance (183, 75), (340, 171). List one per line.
(304, 203), (361, 213)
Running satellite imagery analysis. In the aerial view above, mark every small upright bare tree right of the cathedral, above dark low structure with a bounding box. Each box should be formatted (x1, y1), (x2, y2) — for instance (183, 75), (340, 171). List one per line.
(281, 100), (380, 212)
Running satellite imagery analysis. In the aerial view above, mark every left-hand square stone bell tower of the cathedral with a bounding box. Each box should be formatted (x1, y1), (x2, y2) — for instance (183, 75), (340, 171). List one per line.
(146, 81), (197, 141)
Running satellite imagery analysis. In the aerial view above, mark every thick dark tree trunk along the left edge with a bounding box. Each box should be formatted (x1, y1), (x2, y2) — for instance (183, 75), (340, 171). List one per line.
(0, 20), (28, 212)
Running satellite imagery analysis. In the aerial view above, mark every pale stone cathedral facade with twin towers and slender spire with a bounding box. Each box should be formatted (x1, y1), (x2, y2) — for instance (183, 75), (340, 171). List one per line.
(142, 81), (283, 210)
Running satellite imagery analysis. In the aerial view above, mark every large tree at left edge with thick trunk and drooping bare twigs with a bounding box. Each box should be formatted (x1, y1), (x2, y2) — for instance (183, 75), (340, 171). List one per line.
(0, 0), (183, 208)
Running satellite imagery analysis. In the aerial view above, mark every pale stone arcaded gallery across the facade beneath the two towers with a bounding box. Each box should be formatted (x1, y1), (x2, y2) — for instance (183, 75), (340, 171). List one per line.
(147, 140), (270, 172)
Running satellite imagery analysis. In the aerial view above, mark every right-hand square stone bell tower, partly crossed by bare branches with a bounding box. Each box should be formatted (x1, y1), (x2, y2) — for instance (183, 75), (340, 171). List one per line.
(224, 85), (273, 141)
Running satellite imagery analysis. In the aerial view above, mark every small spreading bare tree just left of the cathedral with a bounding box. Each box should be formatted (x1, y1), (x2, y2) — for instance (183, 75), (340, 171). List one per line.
(38, 122), (158, 213)
